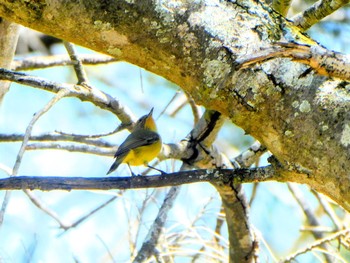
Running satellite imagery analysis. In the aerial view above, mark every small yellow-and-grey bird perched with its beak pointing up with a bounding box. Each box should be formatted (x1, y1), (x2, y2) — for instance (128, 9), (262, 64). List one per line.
(107, 108), (164, 176)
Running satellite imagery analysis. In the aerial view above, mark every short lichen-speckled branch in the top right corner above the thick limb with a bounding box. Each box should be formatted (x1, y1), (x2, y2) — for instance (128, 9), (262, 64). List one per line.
(292, 0), (349, 31)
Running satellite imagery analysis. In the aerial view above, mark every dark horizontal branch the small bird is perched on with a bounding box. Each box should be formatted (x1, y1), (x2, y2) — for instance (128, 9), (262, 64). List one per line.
(0, 166), (281, 191)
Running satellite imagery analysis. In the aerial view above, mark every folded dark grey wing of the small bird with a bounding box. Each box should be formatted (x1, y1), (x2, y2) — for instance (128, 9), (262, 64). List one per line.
(114, 129), (160, 157)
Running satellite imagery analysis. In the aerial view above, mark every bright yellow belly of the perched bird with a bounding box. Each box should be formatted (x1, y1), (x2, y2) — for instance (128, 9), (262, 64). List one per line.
(123, 140), (162, 166)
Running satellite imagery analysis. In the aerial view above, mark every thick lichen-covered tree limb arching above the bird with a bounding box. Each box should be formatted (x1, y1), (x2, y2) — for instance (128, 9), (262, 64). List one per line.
(0, 0), (350, 219)
